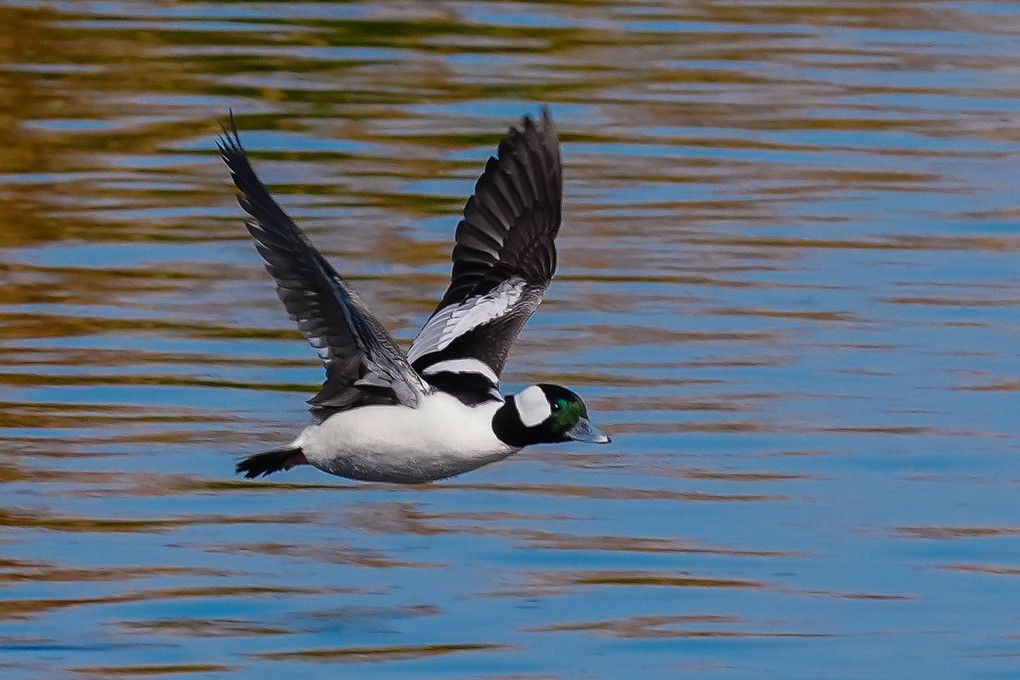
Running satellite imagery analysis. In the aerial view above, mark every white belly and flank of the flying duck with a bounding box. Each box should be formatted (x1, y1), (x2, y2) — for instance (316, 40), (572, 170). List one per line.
(295, 393), (518, 483)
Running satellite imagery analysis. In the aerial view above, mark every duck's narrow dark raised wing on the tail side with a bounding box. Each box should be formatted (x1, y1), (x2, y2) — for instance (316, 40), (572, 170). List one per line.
(218, 116), (431, 411)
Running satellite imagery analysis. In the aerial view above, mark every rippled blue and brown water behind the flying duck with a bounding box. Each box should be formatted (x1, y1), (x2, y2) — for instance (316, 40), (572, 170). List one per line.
(0, 0), (1020, 679)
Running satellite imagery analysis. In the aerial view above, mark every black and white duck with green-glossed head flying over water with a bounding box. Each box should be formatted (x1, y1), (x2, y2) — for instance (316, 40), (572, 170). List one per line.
(218, 109), (609, 483)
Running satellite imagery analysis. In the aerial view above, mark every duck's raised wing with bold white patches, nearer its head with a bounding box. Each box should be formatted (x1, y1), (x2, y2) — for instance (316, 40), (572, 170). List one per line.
(408, 109), (563, 396)
